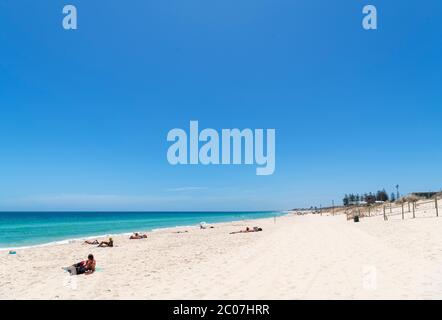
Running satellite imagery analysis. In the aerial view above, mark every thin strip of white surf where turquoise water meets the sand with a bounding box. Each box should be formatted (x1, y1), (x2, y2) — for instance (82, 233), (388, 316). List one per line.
(0, 210), (292, 253)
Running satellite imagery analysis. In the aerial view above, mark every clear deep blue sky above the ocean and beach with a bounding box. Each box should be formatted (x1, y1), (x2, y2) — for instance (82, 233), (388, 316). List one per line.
(0, 0), (442, 210)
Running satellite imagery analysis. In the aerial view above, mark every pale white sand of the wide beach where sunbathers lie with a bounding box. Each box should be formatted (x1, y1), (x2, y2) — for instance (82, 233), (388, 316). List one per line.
(0, 208), (442, 299)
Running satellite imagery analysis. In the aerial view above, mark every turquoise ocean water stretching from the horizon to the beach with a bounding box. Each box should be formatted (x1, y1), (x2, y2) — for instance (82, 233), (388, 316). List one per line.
(0, 211), (284, 249)
